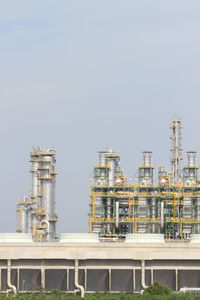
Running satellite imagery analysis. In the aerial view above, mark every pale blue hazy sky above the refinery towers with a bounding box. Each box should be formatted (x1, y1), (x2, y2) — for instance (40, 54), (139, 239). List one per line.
(0, 0), (200, 232)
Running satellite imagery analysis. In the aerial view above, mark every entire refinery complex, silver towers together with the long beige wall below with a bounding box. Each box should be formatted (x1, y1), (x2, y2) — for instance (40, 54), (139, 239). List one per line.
(0, 117), (200, 297)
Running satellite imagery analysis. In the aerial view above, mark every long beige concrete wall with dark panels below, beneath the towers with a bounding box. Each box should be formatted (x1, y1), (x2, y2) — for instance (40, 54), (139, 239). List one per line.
(0, 242), (200, 293)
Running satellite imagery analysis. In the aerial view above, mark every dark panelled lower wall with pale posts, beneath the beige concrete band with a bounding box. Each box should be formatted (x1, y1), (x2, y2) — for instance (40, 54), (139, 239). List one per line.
(0, 259), (200, 293)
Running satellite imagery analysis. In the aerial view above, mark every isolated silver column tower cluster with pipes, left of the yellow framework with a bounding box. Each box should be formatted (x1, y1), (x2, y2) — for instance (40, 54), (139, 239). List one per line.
(16, 147), (57, 241)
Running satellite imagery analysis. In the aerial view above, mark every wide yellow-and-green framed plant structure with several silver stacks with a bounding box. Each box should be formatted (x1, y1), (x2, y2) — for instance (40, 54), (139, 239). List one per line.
(89, 118), (200, 240)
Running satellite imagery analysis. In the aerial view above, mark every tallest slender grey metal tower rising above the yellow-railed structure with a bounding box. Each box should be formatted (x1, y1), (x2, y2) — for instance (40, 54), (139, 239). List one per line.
(170, 117), (183, 183)
